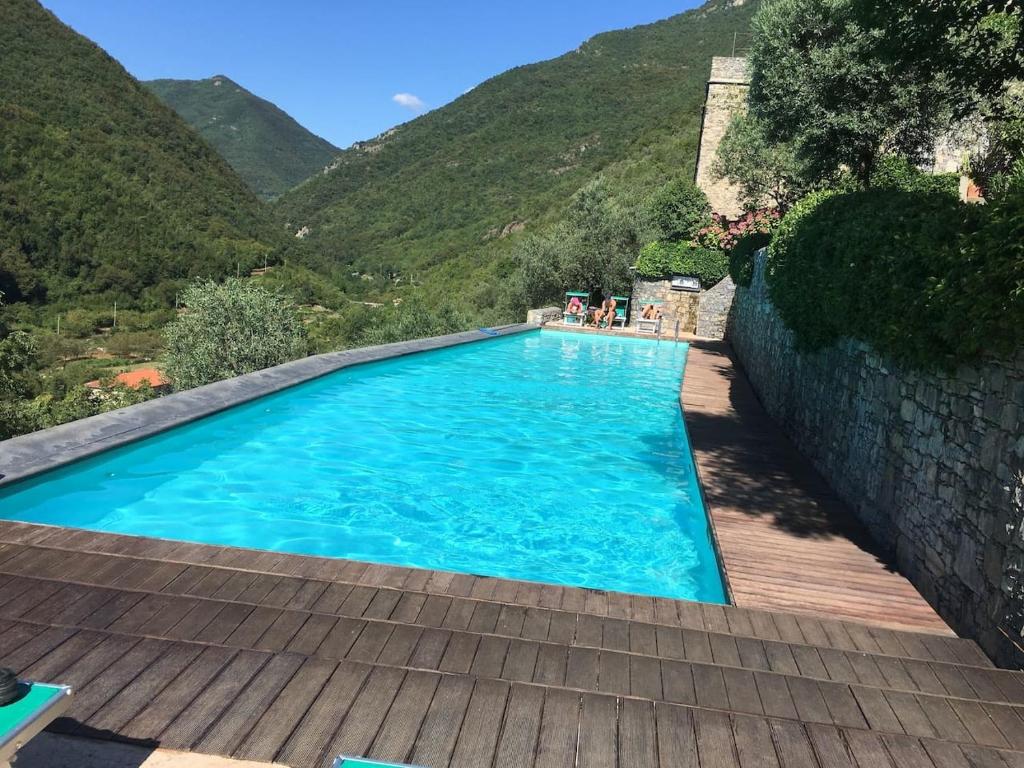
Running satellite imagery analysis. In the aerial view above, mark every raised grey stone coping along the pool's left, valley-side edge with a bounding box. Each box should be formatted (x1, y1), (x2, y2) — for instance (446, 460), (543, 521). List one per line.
(0, 323), (541, 487)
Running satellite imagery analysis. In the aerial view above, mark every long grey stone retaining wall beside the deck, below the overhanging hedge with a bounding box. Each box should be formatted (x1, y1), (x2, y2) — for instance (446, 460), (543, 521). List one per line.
(728, 253), (1024, 667)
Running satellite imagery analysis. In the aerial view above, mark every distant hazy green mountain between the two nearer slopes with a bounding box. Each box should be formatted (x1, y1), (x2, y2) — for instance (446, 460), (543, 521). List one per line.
(143, 75), (339, 200)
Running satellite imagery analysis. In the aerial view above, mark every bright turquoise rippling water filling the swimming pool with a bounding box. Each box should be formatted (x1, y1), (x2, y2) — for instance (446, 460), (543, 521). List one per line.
(0, 331), (725, 602)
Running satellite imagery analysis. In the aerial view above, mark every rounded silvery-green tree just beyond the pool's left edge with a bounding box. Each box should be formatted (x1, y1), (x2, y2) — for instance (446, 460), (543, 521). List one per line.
(165, 279), (306, 389)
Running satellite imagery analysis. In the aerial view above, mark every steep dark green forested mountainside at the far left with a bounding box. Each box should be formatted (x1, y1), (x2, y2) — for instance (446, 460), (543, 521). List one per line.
(0, 0), (286, 306)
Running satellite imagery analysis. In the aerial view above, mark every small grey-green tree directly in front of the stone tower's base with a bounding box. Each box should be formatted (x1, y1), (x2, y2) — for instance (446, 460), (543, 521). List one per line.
(712, 114), (811, 211)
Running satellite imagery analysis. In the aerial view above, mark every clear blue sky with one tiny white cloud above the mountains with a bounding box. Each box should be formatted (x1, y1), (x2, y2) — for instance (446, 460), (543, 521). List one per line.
(42, 0), (700, 147)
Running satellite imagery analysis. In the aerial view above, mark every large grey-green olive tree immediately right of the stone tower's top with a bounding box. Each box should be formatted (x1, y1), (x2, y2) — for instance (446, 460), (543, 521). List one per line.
(750, 0), (953, 185)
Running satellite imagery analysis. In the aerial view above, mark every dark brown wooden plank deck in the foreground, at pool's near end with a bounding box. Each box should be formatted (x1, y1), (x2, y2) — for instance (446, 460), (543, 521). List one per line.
(0, 522), (1024, 768)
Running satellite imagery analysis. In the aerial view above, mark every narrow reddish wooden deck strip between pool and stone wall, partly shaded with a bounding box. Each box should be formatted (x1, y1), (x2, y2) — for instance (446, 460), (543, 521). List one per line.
(682, 341), (950, 633)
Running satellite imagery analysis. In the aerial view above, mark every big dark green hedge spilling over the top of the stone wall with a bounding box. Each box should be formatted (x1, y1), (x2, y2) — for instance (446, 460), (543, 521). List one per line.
(768, 188), (1024, 368)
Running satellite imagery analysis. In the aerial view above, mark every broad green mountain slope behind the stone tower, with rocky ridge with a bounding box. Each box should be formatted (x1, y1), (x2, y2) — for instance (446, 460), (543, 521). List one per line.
(272, 0), (757, 299)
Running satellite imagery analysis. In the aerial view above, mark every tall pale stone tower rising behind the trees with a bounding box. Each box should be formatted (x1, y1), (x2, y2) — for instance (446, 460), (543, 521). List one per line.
(694, 56), (751, 217)
